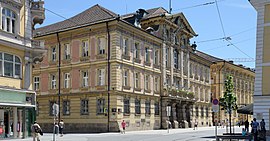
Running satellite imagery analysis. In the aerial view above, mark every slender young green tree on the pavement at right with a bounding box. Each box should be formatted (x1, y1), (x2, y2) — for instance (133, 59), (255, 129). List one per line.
(219, 75), (237, 134)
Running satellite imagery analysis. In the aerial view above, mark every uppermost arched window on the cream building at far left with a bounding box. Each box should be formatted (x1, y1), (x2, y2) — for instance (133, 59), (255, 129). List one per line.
(2, 8), (17, 34)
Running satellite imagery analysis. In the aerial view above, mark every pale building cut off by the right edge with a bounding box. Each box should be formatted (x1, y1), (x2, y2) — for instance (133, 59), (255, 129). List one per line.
(250, 0), (270, 132)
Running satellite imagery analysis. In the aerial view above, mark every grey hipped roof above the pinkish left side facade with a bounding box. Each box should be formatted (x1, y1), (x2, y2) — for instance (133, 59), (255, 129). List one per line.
(34, 4), (118, 36)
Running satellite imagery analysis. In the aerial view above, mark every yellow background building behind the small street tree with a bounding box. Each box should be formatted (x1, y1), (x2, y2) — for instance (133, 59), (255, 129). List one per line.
(197, 51), (255, 123)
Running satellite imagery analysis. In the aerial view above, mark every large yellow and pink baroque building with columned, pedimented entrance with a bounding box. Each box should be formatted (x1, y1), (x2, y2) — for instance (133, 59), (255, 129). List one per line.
(33, 5), (212, 132)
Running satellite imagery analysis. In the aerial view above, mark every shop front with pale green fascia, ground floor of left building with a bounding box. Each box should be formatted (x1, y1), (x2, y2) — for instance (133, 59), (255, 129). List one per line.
(0, 88), (35, 140)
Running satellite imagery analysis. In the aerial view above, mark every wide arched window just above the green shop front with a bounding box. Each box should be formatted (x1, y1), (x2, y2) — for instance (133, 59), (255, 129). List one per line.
(0, 53), (22, 78)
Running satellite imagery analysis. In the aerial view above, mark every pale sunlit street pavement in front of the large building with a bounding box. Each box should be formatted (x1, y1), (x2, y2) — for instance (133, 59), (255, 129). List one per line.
(5, 126), (249, 141)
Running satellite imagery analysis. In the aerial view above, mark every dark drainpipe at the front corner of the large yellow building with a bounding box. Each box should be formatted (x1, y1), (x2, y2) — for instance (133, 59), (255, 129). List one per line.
(106, 22), (111, 132)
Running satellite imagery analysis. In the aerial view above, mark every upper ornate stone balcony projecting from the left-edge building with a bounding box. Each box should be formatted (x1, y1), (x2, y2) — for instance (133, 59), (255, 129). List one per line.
(31, 0), (45, 29)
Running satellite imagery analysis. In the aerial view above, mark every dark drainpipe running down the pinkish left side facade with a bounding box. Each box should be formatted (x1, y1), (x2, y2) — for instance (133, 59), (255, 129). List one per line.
(56, 32), (61, 122)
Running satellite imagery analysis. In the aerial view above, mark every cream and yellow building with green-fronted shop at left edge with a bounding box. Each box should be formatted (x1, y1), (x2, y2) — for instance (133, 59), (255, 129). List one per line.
(0, 0), (45, 140)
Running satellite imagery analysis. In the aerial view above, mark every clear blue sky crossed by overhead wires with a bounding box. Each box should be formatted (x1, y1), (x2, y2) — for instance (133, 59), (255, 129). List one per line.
(37, 0), (257, 68)
